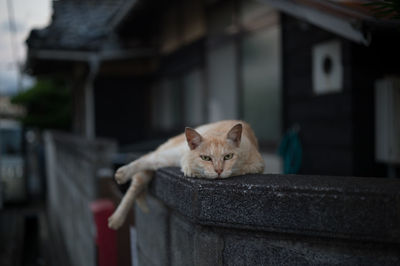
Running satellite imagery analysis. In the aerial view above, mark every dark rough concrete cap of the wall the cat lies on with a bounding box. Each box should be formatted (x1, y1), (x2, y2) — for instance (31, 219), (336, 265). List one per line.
(150, 168), (400, 243)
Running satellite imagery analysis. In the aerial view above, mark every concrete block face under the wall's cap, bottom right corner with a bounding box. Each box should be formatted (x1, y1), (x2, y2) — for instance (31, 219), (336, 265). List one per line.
(220, 232), (400, 266)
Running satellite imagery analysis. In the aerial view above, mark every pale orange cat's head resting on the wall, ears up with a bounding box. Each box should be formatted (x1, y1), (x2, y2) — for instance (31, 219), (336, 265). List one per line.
(185, 124), (243, 179)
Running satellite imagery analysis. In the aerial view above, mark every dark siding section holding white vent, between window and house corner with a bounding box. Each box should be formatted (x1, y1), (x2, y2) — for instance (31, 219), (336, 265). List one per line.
(281, 15), (354, 175)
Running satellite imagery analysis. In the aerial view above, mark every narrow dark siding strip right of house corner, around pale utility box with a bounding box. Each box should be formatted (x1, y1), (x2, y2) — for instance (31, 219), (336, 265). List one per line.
(351, 31), (400, 176)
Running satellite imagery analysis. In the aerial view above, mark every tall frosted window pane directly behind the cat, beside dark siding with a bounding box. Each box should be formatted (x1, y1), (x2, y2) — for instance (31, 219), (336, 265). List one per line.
(241, 10), (282, 144)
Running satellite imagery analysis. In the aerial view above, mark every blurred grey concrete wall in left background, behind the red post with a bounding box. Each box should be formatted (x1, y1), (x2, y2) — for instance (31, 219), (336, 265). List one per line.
(45, 132), (116, 266)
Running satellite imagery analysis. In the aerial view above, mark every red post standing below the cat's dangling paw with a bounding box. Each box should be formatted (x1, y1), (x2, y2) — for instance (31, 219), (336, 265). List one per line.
(90, 199), (118, 266)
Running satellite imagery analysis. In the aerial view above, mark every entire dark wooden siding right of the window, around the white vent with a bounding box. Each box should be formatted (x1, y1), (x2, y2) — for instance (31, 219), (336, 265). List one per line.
(281, 15), (400, 176)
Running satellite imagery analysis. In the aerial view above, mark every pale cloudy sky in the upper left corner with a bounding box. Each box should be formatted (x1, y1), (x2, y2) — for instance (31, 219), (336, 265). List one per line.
(0, 0), (52, 96)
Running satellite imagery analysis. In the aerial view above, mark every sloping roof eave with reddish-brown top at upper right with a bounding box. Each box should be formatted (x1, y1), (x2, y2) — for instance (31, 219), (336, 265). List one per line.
(261, 0), (400, 45)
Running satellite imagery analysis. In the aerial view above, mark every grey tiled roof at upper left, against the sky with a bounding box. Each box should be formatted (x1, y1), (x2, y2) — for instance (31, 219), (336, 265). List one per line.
(27, 0), (136, 51)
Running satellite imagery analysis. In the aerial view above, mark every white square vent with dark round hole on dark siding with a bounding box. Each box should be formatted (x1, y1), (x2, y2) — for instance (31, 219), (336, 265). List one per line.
(312, 40), (343, 94)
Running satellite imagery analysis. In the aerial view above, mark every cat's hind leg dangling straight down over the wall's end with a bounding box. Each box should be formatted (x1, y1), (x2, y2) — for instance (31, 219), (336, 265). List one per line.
(108, 171), (153, 230)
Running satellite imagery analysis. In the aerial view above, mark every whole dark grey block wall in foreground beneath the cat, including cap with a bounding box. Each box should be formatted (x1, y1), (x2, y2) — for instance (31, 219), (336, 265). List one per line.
(136, 168), (400, 266)
